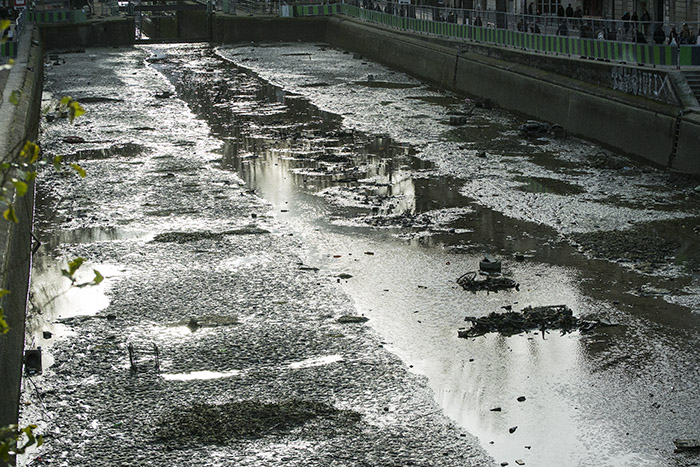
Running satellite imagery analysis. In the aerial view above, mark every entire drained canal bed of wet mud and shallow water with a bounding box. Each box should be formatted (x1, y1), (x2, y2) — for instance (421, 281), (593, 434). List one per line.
(24, 44), (700, 466)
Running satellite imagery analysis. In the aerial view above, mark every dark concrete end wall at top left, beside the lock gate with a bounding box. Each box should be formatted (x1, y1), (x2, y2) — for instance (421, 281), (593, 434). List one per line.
(41, 17), (135, 50)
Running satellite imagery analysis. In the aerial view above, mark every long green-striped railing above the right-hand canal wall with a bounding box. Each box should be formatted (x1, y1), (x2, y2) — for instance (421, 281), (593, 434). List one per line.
(284, 3), (700, 66)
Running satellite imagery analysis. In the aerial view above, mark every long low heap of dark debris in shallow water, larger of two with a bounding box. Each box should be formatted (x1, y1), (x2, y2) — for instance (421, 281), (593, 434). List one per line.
(457, 305), (616, 338)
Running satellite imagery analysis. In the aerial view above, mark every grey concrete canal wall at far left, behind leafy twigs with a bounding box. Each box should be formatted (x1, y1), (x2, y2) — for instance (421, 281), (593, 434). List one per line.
(0, 24), (43, 426)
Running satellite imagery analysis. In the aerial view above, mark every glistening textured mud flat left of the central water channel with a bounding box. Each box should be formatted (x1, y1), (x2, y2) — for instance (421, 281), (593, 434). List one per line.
(22, 49), (492, 466)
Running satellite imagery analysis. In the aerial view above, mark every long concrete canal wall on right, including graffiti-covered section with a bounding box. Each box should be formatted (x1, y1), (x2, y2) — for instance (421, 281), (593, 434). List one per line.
(326, 17), (700, 175)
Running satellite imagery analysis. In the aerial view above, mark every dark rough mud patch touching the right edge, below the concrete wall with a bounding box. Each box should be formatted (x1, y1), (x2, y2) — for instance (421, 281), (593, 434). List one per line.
(570, 218), (700, 271)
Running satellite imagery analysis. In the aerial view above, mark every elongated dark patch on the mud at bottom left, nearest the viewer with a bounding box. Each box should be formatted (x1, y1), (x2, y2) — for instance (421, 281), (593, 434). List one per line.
(154, 399), (361, 447)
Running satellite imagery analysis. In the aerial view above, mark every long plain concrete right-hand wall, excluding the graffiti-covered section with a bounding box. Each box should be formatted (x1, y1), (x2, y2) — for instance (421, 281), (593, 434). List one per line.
(327, 18), (700, 175)
